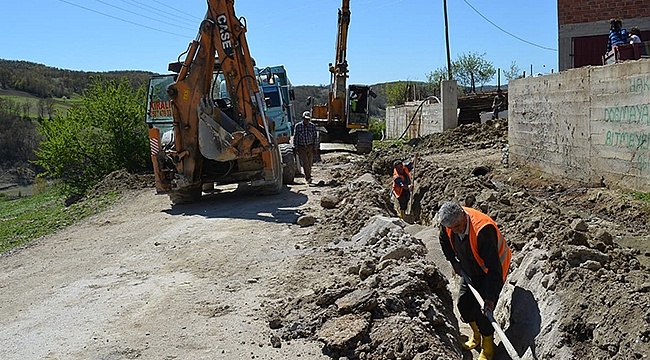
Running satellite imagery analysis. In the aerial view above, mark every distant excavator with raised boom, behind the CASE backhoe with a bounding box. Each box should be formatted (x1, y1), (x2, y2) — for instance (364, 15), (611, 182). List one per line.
(309, 0), (376, 154)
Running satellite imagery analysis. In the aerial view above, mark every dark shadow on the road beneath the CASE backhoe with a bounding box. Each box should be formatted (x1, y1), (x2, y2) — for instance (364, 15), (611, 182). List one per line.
(163, 186), (307, 224)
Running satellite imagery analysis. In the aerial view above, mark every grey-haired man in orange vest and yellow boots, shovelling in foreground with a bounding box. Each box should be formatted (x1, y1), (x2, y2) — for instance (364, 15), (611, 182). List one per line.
(438, 202), (512, 360)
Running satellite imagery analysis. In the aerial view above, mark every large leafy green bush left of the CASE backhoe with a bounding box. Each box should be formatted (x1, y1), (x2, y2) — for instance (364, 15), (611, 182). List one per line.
(35, 78), (149, 195)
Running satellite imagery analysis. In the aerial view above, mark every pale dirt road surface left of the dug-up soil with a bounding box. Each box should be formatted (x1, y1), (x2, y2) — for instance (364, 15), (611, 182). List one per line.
(0, 185), (330, 360)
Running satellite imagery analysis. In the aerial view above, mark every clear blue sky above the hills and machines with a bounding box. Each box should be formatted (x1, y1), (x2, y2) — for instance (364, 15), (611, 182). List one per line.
(0, 0), (558, 85)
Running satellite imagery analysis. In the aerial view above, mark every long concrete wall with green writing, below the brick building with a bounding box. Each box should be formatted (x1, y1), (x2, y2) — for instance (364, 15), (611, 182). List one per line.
(508, 60), (650, 191)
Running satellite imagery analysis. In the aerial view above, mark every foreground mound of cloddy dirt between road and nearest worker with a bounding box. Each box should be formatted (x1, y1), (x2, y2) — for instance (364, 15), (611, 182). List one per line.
(266, 216), (460, 359)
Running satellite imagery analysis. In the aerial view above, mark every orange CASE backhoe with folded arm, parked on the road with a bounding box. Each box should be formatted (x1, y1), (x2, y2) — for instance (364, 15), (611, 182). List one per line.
(147, 0), (282, 204)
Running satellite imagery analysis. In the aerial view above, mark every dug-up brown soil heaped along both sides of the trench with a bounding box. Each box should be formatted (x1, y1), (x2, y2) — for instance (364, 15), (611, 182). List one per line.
(269, 121), (650, 359)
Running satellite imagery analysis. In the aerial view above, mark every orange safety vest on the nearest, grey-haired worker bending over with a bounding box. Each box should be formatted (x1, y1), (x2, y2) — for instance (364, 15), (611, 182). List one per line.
(446, 206), (512, 284)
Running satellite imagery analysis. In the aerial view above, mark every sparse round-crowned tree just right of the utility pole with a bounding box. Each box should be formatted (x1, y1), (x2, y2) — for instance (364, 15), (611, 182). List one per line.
(451, 52), (497, 92)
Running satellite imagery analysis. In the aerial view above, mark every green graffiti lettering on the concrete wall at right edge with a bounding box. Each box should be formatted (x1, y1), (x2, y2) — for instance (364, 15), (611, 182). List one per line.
(604, 76), (650, 174)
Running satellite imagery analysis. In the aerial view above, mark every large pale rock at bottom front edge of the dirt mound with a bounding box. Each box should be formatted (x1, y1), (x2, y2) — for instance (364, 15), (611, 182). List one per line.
(318, 313), (370, 351)
